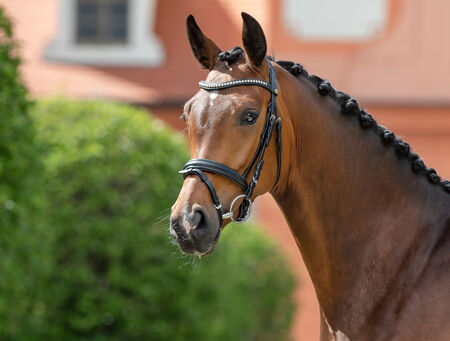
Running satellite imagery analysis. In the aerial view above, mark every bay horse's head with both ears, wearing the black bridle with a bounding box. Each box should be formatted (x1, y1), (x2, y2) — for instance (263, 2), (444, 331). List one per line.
(170, 13), (281, 255)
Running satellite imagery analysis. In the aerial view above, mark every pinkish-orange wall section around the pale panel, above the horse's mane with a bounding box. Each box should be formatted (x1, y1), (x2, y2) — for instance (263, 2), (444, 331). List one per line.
(270, 0), (450, 106)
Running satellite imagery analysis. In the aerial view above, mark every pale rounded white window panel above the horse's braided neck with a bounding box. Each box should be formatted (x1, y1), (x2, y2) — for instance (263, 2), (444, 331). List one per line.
(283, 0), (387, 41)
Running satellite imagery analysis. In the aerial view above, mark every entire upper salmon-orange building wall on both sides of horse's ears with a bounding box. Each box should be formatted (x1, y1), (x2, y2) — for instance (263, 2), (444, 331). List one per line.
(5, 0), (450, 106)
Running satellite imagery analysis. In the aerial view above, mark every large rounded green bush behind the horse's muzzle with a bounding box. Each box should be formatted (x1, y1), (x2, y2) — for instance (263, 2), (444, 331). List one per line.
(0, 99), (294, 341)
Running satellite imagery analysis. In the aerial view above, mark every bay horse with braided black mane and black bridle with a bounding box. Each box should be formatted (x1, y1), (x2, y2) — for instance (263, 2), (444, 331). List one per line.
(170, 13), (450, 341)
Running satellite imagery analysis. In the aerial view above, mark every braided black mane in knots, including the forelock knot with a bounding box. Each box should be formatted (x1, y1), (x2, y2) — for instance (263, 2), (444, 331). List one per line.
(219, 47), (450, 193)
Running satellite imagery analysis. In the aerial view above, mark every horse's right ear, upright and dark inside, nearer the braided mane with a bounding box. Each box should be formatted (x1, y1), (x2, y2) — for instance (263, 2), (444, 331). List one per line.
(241, 12), (267, 67)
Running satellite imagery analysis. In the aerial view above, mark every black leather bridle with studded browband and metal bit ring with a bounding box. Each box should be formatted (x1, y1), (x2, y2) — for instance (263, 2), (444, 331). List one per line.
(180, 60), (281, 228)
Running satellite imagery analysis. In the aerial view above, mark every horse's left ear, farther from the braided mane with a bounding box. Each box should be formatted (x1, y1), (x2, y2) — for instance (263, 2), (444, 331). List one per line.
(186, 15), (222, 70)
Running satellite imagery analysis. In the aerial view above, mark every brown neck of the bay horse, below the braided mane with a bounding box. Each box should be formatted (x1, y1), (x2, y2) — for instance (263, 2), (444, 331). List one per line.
(272, 75), (450, 330)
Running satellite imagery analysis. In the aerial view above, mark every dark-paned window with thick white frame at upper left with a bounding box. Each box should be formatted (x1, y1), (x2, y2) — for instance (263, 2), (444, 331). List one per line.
(45, 0), (164, 66)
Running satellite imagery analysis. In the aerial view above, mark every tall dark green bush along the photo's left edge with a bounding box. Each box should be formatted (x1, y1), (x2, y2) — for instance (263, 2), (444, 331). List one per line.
(0, 6), (51, 340)
